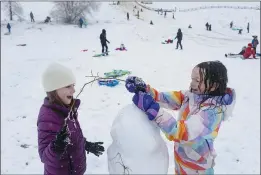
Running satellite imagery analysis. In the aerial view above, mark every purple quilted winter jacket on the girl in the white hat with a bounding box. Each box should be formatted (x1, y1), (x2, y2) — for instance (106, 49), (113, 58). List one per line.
(37, 97), (86, 175)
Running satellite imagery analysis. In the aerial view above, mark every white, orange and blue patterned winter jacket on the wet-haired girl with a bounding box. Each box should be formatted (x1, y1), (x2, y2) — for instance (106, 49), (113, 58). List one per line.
(147, 85), (236, 174)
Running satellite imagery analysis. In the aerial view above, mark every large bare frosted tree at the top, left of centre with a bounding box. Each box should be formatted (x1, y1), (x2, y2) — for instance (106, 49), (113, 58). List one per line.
(51, 1), (99, 24)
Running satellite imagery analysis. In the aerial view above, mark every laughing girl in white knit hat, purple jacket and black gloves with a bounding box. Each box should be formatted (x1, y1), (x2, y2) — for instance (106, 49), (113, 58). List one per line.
(37, 63), (104, 175)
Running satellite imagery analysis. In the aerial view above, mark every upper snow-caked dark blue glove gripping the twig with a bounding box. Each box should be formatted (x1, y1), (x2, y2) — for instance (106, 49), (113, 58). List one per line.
(125, 76), (146, 93)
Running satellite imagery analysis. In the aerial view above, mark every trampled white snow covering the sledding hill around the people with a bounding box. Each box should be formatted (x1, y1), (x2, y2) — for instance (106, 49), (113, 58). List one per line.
(1, 2), (260, 174)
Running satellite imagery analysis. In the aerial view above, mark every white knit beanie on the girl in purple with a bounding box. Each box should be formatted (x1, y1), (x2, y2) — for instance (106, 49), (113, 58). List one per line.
(42, 63), (76, 92)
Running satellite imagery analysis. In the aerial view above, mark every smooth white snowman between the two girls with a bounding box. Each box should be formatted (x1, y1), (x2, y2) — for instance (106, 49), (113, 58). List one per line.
(107, 104), (169, 174)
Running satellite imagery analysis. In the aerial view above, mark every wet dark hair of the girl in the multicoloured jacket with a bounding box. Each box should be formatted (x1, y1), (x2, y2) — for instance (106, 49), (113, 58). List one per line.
(192, 61), (228, 108)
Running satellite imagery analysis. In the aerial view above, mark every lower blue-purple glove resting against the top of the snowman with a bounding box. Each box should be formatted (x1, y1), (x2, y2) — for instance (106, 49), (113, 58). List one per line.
(132, 92), (160, 120)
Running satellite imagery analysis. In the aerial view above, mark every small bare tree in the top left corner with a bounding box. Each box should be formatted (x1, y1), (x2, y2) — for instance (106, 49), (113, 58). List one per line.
(1, 1), (23, 21)
